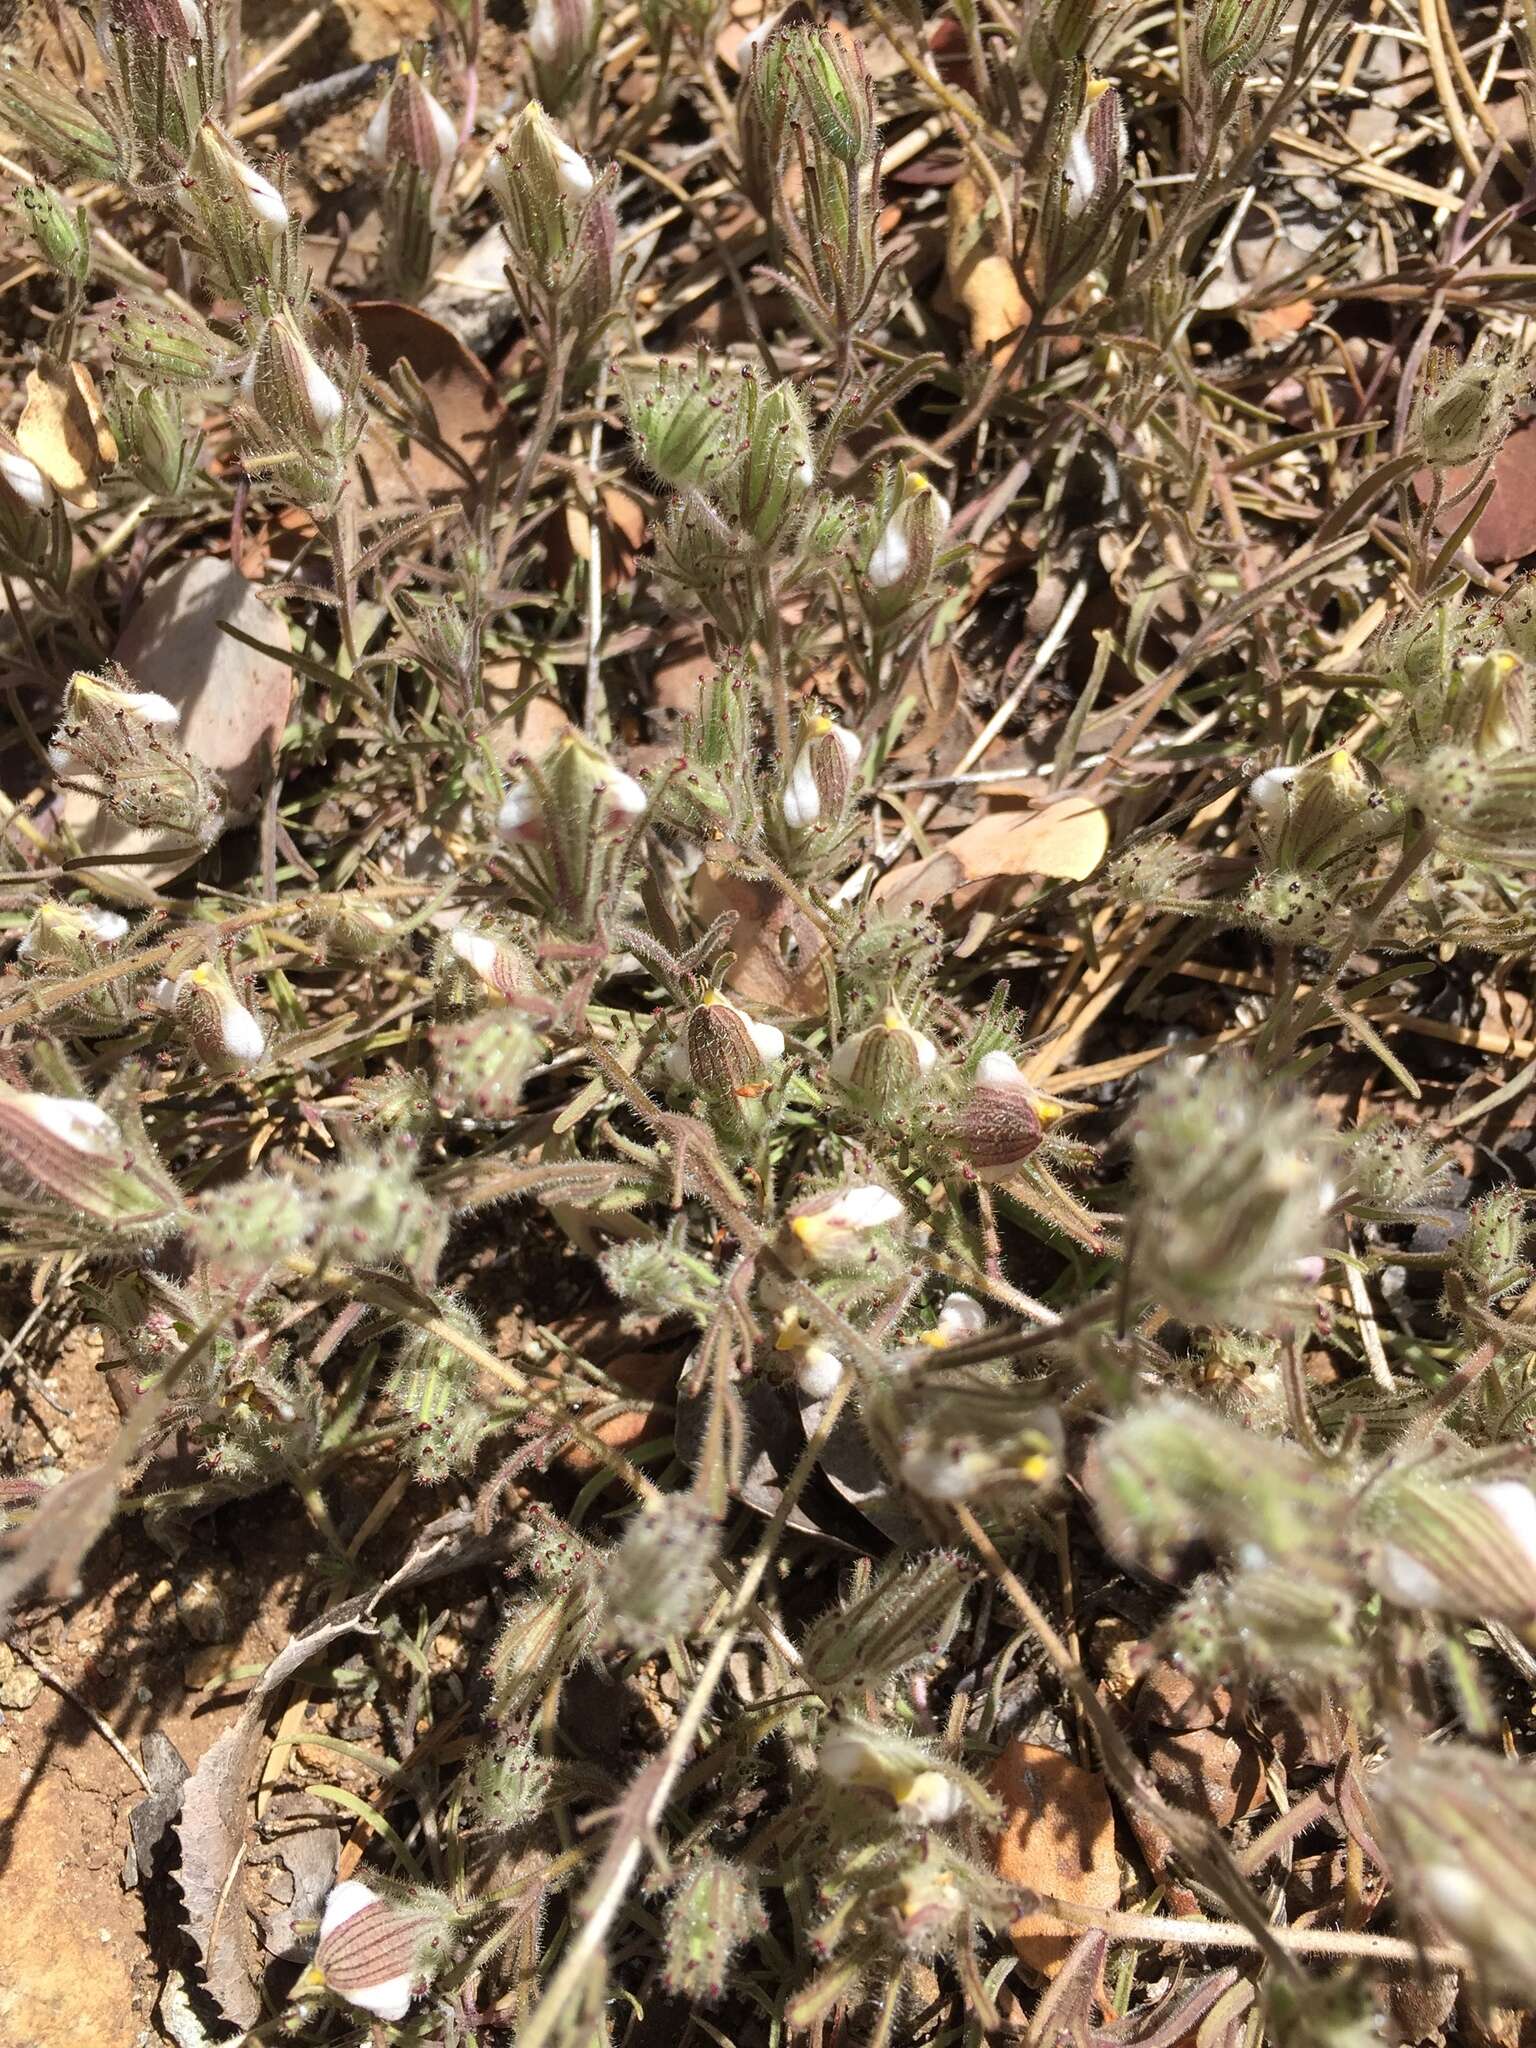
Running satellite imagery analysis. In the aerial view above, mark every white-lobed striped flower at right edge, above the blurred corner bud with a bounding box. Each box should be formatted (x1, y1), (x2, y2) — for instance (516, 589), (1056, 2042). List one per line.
(1368, 1479), (1536, 1628)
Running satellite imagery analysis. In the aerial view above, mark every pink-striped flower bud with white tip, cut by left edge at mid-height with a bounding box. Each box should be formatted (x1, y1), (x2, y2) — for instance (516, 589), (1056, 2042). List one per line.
(0, 1087), (180, 1229)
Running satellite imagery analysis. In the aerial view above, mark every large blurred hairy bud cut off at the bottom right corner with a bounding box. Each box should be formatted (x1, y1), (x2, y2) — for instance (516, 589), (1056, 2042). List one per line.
(1370, 1741), (1536, 2005)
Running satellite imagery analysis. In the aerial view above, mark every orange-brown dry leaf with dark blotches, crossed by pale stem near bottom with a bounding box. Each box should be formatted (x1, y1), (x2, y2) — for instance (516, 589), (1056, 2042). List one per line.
(991, 1741), (1120, 1976)
